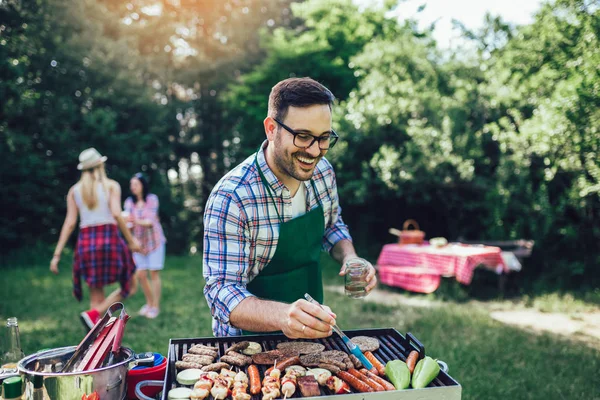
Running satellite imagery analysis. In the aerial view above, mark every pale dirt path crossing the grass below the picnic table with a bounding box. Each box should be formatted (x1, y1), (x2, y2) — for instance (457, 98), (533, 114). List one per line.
(326, 286), (600, 348)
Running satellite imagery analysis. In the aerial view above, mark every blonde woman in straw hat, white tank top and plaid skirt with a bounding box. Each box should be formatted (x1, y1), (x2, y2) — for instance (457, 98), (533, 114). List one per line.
(50, 148), (140, 329)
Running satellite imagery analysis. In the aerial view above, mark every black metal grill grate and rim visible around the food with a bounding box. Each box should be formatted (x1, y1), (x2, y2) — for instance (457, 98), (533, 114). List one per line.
(162, 328), (460, 400)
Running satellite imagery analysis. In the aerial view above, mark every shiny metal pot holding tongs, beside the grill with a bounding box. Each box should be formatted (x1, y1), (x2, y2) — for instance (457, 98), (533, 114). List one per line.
(18, 346), (136, 400)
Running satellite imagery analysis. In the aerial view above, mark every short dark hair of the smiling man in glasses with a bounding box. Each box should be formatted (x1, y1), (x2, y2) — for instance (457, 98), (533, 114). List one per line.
(268, 77), (335, 121)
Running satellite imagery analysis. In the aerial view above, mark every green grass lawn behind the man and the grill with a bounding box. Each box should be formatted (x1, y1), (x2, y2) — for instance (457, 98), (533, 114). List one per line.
(0, 256), (600, 400)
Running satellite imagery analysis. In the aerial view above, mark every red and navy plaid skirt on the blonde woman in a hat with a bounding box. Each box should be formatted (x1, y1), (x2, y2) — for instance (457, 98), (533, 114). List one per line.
(73, 224), (135, 301)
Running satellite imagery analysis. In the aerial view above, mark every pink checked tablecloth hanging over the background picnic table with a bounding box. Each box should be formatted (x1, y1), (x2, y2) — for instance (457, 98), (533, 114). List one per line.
(377, 244), (508, 286)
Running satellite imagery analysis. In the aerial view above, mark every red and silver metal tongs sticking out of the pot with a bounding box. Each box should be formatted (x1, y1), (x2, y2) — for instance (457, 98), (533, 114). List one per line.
(62, 303), (129, 372)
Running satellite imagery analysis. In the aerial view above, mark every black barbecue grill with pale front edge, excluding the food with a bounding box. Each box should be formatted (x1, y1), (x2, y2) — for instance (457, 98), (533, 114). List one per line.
(157, 328), (462, 400)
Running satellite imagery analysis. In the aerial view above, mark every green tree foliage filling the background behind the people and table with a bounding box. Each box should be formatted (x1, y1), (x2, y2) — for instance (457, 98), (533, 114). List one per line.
(0, 0), (600, 286)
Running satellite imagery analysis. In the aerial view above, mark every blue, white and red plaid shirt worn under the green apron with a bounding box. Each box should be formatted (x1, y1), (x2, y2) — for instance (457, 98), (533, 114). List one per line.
(203, 143), (352, 336)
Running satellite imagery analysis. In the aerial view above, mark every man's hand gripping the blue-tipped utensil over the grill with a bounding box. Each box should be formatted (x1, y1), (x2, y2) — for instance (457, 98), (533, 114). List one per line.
(281, 299), (336, 339)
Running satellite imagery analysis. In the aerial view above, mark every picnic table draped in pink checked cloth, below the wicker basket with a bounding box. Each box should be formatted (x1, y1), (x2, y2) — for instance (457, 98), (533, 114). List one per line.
(377, 243), (508, 293)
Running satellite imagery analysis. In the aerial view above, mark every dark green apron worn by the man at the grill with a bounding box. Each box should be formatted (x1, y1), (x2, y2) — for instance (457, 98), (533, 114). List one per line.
(244, 149), (325, 334)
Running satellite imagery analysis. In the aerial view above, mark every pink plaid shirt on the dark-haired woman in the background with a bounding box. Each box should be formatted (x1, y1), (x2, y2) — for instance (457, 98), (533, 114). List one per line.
(123, 193), (167, 254)
